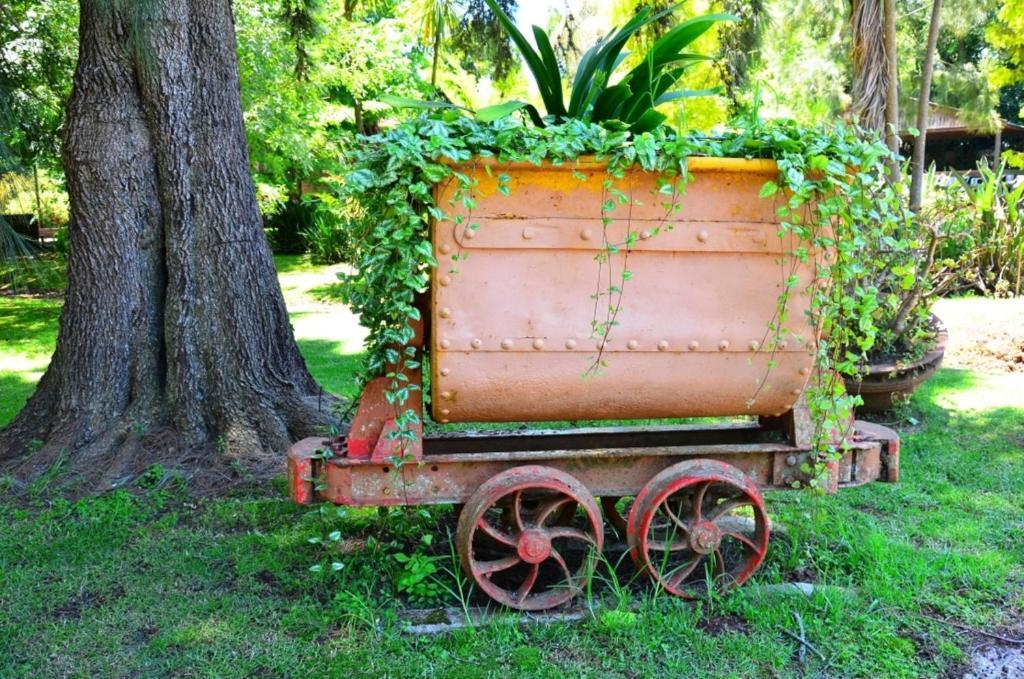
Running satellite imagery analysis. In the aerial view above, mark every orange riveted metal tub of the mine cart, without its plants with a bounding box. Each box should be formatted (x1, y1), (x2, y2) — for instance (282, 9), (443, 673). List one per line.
(430, 158), (816, 422)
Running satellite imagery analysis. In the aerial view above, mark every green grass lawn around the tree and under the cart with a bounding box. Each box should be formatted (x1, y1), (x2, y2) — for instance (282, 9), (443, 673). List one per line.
(0, 258), (1024, 677)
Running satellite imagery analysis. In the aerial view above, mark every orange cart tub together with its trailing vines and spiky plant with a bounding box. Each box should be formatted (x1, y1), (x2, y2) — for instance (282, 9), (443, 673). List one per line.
(333, 0), (912, 467)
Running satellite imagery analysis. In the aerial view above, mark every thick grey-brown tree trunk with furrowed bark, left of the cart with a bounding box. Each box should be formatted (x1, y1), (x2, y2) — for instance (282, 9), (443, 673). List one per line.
(0, 0), (330, 487)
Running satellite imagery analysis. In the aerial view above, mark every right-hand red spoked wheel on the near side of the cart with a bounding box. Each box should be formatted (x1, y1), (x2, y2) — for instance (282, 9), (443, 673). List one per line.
(627, 460), (769, 599)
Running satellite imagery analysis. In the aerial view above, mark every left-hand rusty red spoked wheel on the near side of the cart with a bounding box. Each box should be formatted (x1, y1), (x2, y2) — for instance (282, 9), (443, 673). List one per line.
(456, 465), (604, 610)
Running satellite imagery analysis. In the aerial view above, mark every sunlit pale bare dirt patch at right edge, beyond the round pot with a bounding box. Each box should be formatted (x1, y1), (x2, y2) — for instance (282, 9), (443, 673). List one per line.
(933, 298), (1024, 373)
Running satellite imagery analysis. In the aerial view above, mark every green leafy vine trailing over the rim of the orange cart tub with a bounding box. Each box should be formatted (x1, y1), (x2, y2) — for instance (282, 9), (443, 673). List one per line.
(339, 111), (919, 483)
